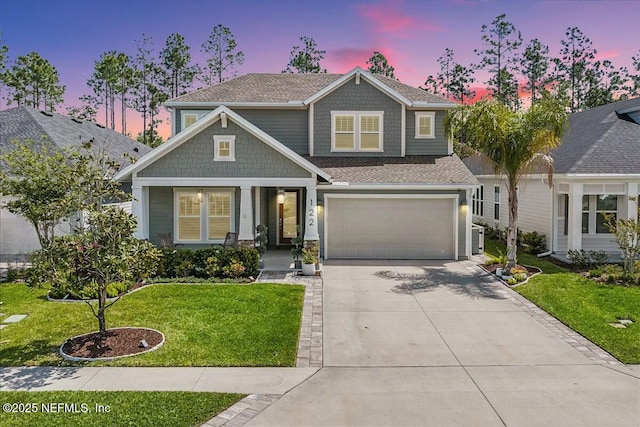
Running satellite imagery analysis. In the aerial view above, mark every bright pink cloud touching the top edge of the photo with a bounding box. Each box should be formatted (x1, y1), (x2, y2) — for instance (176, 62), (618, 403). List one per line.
(356, 0), (442, 38)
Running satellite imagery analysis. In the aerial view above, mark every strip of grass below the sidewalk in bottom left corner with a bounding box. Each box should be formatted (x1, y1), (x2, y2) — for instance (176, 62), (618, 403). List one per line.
(0, 391), (244, 427)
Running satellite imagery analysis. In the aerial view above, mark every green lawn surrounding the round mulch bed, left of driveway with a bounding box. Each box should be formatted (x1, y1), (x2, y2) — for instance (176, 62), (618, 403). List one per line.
(0, 284), (304, 366)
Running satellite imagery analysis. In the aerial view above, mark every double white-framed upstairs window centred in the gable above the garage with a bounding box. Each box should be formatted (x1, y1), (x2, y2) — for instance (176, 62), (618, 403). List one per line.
(331, 111), (383, 151)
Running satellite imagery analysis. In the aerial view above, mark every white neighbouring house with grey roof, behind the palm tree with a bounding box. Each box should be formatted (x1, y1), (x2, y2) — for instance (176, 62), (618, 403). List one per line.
(464, 98), (640, 258)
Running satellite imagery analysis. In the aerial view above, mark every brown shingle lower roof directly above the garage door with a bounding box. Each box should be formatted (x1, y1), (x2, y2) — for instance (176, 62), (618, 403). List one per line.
(305, 154), (478, 185)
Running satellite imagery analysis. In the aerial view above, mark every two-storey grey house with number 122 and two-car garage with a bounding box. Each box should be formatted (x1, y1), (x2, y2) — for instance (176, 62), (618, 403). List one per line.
(117, 68), (478, 259)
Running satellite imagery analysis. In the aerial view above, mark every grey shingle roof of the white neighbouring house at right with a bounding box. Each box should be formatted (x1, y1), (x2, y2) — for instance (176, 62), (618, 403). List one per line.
(464, 98), (640, 175)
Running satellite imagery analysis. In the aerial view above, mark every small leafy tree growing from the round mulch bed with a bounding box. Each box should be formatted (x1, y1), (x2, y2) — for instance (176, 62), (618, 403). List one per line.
(25, 143), (160, 337)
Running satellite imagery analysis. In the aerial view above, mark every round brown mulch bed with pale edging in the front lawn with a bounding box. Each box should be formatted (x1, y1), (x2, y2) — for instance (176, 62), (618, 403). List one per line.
(62, 328), (163, 358)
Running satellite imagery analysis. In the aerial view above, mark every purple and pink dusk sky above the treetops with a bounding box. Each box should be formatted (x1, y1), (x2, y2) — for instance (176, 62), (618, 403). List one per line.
(0, 0), (640, 137)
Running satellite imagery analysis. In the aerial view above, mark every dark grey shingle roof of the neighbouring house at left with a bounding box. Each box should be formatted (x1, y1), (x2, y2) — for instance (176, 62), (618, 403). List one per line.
(0, 106), (151, 166)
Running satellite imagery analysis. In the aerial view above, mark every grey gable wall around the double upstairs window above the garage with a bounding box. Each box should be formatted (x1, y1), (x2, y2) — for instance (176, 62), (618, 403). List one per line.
(313, 79), (402, 157)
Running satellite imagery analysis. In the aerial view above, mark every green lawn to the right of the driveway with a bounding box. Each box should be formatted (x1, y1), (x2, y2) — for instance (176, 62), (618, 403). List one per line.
(485, 240), (640, 364)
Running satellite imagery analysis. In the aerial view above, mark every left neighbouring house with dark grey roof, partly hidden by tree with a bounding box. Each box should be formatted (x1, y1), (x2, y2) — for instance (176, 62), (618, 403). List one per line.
(0, 106), (151, 261)
